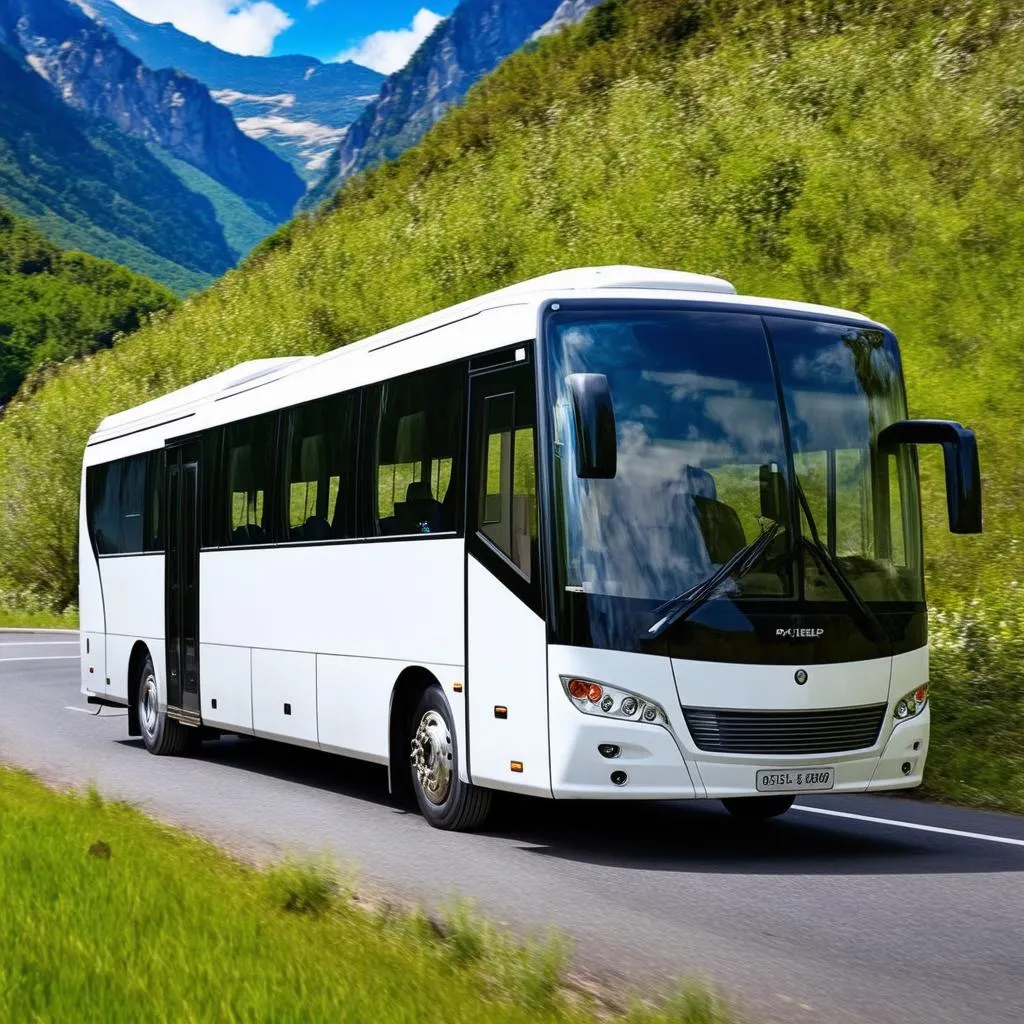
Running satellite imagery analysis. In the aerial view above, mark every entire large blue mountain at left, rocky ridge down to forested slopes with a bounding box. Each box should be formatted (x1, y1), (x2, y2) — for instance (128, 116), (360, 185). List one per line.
(0, 0), (304, 292)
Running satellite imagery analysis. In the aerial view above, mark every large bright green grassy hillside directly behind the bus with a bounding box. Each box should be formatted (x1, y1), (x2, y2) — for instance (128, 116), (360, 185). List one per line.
(0, 0), (1024, 809)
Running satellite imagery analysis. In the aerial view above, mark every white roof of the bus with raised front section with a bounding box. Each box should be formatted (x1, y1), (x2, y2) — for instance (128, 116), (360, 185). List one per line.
(89, 266), (870, 445)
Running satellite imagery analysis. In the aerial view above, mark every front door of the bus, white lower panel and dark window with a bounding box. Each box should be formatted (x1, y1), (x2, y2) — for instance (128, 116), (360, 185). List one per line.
(466, 356), (551, 796)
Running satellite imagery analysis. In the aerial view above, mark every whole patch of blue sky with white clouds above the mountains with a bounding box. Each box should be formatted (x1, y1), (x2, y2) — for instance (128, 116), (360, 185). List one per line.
(110, 0), (458, 74)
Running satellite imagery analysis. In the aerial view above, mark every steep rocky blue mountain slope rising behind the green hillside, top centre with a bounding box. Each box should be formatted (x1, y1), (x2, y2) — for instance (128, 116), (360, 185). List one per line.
(303, 0), (596, 208)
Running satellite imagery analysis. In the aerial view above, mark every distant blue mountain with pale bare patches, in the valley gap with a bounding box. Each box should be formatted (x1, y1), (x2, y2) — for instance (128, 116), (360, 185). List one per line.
(75, 0), (384, 180)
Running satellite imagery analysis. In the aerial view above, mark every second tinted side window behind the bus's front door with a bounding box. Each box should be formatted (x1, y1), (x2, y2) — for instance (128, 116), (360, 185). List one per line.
(284, 394), (358, 541)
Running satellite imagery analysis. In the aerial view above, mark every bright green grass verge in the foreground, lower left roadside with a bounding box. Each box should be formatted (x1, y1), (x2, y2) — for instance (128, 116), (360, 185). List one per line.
(0, 768), (727, 1024)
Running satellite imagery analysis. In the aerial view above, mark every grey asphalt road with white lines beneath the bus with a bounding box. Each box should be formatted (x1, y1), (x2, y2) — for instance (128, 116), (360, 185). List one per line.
(0, 633), (1024, 1024)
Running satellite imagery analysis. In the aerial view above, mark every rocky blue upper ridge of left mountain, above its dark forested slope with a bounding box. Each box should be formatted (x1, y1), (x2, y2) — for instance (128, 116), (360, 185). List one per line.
(0, 0), (304, 222)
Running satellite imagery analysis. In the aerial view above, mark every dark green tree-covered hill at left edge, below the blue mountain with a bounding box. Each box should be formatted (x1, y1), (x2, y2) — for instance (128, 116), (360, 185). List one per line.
(0, 209), (177, 407)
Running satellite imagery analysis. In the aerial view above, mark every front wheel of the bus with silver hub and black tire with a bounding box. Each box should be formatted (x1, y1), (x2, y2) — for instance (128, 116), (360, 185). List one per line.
(409, 684), (492, 831)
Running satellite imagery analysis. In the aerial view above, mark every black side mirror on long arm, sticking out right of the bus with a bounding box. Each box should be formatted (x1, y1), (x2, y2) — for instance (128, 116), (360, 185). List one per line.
(879, 420), (981, 534)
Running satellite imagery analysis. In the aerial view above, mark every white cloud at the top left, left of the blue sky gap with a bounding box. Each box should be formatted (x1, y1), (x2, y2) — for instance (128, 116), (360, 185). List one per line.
(118, 0), (292, 56)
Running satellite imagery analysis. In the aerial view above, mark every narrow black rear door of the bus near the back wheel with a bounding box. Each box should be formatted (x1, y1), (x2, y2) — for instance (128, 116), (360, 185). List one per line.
(164, 441), (201, 725)
